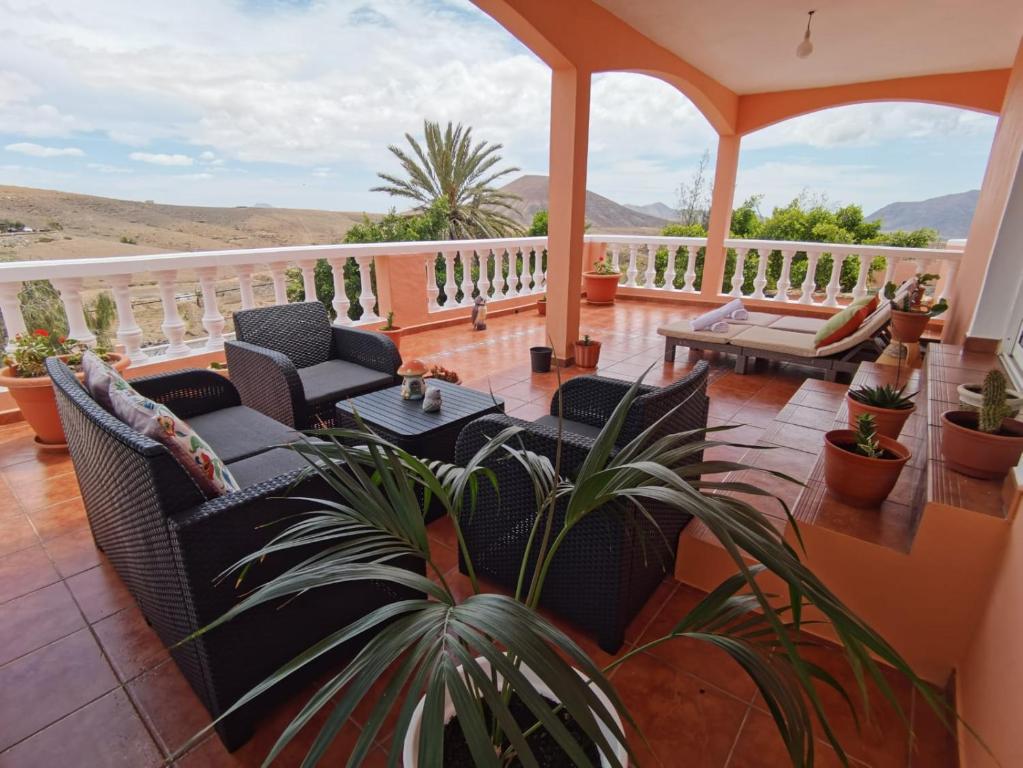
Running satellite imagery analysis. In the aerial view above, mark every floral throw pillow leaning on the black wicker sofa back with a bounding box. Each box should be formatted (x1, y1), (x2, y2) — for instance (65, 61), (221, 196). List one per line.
(109, 376), (239, 498)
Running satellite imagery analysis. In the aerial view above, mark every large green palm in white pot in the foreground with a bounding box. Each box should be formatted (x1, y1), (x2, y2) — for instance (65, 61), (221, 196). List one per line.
(193, 382), (951, 768)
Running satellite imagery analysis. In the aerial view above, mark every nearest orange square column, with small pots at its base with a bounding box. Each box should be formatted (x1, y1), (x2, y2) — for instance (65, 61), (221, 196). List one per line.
(547, 69), (589, 364)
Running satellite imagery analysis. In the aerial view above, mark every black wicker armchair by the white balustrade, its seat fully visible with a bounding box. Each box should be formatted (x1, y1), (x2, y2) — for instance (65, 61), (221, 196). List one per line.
(225, 302), (401, 428)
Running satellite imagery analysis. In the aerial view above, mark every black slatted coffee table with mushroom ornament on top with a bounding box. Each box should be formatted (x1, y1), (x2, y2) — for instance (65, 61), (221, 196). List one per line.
(337, 379), (504, 461)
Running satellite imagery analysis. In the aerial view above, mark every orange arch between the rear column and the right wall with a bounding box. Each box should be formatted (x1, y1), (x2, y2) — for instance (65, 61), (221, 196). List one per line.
(737, 70), (1010, 136)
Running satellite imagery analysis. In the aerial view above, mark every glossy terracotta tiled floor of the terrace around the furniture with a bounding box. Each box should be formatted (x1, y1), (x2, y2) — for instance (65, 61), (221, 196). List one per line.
(0, 302), (955, 768)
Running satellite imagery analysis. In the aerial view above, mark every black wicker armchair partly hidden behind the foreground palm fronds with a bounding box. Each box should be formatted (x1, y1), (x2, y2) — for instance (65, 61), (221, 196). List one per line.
(455, 362), (708, 653)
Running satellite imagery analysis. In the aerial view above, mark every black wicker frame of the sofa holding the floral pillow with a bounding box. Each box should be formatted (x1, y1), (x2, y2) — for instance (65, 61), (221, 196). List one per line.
(46, 358), (421, 750)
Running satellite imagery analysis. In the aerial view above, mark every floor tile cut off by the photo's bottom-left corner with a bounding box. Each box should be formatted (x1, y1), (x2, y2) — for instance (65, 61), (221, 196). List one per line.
(0, 688), (164, 768)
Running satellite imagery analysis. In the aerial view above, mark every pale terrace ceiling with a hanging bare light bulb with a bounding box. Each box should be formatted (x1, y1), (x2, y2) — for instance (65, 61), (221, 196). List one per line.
(593, 0), (1023, 94)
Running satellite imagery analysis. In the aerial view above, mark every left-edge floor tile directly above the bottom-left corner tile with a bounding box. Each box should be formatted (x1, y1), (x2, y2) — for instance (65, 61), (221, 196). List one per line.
(0, 630), (117, 750)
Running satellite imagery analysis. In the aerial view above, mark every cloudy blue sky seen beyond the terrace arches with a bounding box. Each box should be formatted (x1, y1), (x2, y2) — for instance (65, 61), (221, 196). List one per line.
(0, 0), (994, 216)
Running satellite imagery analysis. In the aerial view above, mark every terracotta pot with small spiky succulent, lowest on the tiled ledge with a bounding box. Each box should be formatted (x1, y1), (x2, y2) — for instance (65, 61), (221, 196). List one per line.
(825, 430), (913, 509)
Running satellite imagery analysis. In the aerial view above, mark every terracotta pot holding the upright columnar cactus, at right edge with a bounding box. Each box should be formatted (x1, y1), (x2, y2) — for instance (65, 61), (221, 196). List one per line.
(941, 411), (1023, 480)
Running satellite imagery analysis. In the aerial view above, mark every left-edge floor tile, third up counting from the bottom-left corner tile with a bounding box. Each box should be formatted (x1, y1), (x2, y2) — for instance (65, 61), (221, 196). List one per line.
(0, 583), (85, 665)
